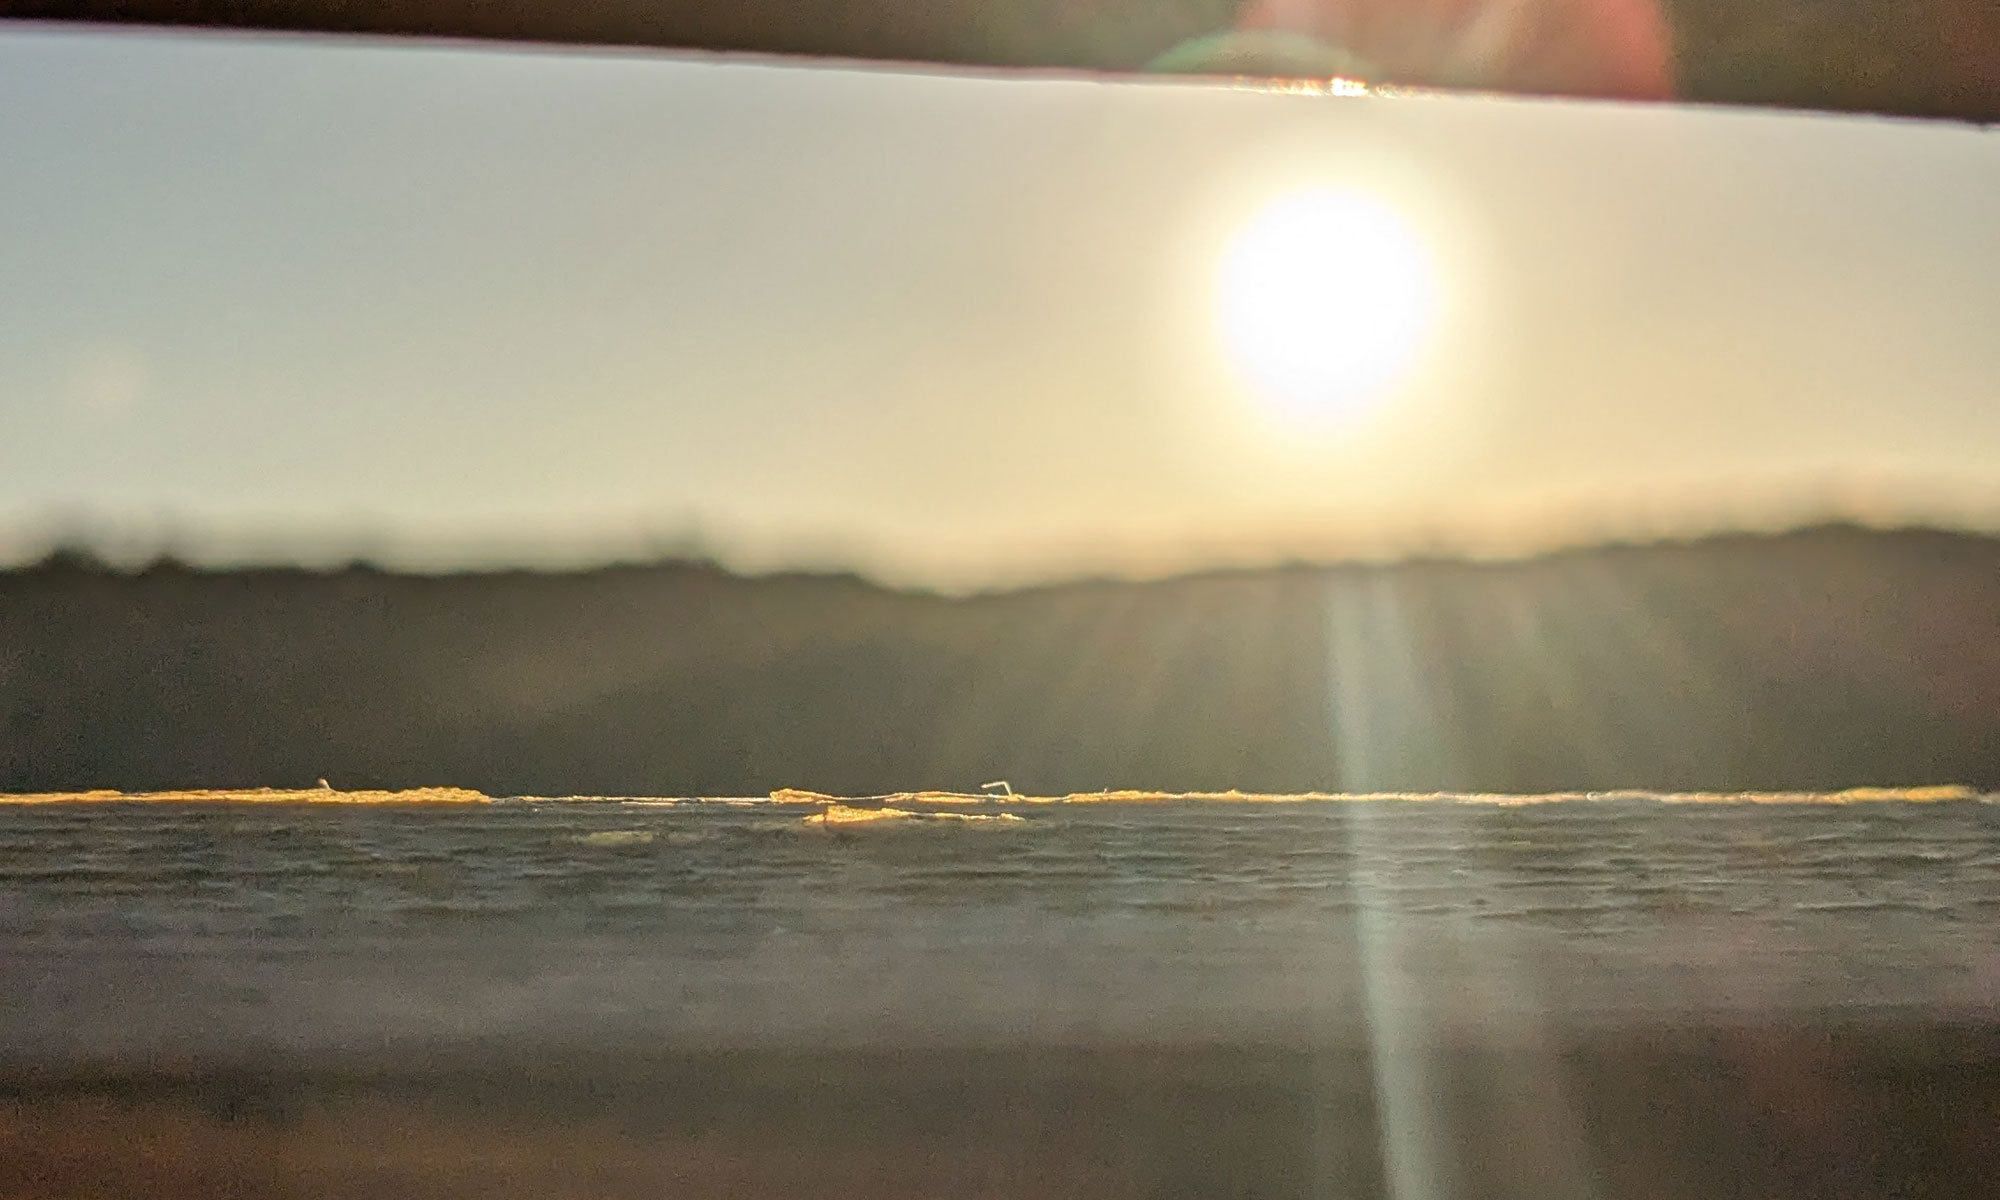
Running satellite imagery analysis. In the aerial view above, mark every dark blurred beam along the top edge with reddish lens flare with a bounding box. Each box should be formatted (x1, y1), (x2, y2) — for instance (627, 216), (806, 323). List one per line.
(11, 0), (2000, 122)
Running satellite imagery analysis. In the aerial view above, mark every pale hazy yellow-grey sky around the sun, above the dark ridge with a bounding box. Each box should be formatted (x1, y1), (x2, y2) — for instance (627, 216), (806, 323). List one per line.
(0, 26), (2000, 584)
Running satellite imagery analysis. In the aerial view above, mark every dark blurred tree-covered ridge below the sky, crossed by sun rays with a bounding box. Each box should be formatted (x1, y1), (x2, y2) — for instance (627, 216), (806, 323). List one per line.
(0, 528), (2000, 794)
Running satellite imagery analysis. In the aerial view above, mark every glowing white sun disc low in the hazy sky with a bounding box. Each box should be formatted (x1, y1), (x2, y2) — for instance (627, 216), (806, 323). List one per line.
(1216, 188), (1438, 424)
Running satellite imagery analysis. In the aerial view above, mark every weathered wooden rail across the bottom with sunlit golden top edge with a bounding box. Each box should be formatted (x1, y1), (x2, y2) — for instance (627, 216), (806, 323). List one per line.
(0, 798), (2000, 1196)
